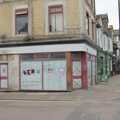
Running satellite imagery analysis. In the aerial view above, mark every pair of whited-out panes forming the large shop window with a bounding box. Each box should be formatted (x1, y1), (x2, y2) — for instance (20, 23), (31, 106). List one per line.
(21, 60), (67, 90)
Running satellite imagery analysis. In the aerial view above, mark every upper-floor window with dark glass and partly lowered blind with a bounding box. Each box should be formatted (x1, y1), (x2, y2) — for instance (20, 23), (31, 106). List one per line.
(15, 8), (28, 35)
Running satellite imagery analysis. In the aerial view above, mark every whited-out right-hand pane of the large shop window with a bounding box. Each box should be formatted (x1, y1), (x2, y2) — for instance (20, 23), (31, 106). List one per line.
(43, 60), (67, 90)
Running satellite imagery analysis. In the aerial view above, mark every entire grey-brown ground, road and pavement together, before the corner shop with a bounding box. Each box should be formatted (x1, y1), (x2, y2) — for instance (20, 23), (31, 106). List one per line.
(0, 76), (120, 120)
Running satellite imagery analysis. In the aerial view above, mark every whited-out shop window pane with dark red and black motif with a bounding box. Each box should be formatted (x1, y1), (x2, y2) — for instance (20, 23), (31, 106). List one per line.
(21, 61), (42, 90)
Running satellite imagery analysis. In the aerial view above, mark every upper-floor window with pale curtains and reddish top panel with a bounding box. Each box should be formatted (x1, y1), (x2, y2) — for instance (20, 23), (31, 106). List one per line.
(48, 5), (64, 32)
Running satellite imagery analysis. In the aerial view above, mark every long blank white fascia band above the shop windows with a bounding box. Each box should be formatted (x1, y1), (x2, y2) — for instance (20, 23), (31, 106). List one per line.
(0, 43), (97, 56)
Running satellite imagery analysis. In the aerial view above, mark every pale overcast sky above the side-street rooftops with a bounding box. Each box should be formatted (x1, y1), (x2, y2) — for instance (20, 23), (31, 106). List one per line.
(96, 0), (119, 29)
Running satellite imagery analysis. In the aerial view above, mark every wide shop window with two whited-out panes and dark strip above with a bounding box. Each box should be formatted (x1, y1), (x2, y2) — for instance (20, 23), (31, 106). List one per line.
(20, 53), (67, 90)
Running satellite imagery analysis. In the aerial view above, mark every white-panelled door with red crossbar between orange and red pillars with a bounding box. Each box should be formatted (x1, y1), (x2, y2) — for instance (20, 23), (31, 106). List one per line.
(73, 61), (82, 89)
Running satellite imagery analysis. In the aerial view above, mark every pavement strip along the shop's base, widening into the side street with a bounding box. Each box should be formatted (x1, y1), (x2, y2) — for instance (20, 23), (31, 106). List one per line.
(0, 76), (120, 101)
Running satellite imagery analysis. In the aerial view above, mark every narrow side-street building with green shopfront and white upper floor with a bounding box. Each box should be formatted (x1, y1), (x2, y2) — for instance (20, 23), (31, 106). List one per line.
(96, 14), (113, 83)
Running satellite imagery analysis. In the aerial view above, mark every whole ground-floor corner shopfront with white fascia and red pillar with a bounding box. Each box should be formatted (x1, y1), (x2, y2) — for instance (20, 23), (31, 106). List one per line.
(0, 43), (97, 91)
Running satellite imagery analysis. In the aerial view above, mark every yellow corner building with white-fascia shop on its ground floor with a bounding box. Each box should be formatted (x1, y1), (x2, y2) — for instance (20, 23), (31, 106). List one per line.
(0, 0), (97, 91)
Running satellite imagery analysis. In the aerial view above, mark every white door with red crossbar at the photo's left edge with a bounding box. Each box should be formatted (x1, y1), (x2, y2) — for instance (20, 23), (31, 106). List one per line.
(0, 64), (8, 89)
